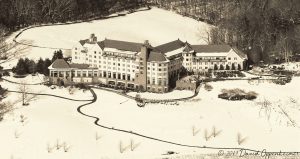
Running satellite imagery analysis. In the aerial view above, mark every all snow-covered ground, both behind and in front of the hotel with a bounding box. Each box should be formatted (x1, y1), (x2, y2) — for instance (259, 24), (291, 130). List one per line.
(0, 5), (300, 159)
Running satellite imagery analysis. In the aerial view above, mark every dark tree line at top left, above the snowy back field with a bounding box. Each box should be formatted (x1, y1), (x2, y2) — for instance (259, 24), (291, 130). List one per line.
(0, 0), (143, 31)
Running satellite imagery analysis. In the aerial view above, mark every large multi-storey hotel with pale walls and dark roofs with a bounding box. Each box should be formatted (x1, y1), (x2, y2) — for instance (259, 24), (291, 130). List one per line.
(49, 34), (247, 92)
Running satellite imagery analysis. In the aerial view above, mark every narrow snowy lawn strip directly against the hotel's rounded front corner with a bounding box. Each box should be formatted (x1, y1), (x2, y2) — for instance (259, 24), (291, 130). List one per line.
(127, 90), (194, 99)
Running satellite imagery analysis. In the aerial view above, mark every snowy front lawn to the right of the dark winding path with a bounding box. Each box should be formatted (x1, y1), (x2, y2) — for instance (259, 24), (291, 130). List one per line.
(83, 78), (300, 151)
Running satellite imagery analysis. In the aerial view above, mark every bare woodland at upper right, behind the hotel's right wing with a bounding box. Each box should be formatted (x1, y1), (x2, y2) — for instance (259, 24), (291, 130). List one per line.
(150, 0), (300, 63)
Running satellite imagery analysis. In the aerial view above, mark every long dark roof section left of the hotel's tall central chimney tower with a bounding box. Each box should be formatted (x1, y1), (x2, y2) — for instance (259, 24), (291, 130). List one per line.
(98, 39), (143, 52)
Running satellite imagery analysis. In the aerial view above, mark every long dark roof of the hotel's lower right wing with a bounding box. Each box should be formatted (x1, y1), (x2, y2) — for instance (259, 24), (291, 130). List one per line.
(191, 45), (231, 53)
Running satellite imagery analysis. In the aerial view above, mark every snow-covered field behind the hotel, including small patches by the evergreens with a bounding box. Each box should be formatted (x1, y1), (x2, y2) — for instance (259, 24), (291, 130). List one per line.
(3, 8), (210, 68)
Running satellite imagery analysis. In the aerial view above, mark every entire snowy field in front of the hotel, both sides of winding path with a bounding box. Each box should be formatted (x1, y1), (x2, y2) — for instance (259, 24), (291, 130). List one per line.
(0, 77), (300, 159)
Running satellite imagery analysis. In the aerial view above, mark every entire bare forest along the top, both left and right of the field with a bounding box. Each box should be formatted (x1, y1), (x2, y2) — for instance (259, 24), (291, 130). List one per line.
(0, 0), (300, 63)
